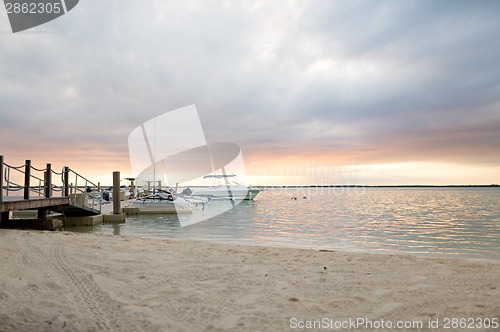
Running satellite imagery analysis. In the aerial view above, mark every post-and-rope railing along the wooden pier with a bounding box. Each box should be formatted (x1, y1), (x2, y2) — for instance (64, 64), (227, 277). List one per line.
(0, 156), (102, 213)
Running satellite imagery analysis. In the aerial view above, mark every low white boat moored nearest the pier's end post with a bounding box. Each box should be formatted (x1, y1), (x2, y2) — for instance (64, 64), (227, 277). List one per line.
(132, 191), (193, 214)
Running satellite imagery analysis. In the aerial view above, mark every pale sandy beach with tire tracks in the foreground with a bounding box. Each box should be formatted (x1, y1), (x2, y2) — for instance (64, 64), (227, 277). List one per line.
(0, 230), (500, 331)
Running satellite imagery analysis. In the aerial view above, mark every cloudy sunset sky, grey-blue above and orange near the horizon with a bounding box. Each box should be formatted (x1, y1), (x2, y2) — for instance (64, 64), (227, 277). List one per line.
(0, 0), (500, 185)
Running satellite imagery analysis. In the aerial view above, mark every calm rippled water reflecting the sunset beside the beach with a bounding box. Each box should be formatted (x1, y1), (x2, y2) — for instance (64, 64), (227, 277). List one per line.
(70, 188), (500, 260)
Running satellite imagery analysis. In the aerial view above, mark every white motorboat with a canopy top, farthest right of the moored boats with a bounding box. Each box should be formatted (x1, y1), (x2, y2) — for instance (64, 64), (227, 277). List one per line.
(190, 174), (261, 200)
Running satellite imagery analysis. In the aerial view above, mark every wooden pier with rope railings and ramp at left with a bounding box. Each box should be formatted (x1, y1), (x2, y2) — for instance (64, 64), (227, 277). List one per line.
(0, 156), (124, 228)
